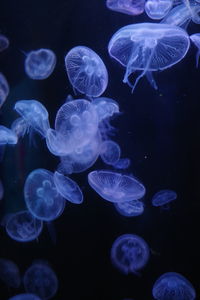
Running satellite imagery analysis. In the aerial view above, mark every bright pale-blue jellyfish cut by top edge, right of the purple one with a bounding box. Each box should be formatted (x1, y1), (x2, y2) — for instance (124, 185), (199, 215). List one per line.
(145, 0), (173, 20)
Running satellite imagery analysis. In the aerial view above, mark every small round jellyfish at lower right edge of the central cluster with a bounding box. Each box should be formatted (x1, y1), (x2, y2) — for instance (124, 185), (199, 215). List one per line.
(100, 140), (121, 166)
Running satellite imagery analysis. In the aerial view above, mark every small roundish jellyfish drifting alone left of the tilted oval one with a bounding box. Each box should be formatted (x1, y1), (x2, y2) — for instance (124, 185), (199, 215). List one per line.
(25, 48), (56, 80)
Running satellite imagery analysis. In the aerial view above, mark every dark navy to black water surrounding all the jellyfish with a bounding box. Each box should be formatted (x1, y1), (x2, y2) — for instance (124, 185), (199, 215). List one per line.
(0, 0), (200, 300)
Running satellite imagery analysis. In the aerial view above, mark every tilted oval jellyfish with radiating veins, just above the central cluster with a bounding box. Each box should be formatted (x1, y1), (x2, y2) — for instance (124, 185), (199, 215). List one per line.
(65, 46), (108, 97)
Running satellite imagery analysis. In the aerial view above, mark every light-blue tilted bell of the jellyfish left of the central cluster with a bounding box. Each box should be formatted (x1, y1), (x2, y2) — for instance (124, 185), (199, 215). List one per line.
(14, 100), (50, 137)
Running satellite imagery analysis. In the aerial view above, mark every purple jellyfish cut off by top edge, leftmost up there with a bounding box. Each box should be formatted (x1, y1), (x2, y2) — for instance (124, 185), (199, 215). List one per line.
(106, 0), (145, 16)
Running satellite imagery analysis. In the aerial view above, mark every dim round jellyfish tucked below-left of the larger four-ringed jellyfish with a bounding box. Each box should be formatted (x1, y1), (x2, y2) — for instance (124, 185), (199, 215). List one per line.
(6, 211), (43, 242)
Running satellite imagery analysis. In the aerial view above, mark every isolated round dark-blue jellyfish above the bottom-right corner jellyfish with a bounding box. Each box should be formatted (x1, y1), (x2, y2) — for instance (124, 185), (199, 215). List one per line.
(111, 234), (150, 275)
